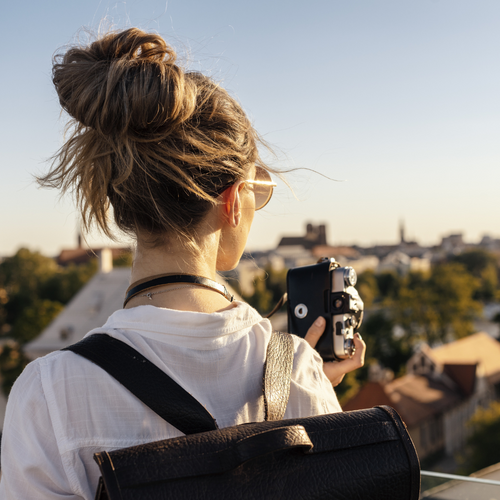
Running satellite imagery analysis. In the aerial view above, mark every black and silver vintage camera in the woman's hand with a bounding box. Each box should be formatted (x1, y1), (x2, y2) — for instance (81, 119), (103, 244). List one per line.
(286, 257), (363, 361)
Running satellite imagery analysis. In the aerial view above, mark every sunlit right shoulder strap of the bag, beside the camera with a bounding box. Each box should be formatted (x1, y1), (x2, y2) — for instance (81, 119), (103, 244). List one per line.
(263, 332), (293, 421)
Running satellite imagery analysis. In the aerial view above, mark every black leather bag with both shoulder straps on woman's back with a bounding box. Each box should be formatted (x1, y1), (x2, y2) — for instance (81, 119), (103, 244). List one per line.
(64, 334), (420, 500)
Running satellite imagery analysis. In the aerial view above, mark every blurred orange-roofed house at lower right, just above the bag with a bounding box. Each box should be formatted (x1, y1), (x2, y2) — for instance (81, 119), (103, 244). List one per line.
(344, 333), (500, 458)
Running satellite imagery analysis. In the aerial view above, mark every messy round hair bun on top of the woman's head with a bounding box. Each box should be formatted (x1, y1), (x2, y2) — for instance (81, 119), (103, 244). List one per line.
(53, 29), (196, 137)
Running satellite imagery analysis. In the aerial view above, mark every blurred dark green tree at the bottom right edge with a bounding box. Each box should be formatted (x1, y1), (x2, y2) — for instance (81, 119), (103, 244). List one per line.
(463, 401), (500, 474)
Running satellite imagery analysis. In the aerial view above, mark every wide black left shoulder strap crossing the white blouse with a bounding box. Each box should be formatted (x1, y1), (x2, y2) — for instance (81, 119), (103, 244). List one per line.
(62, 334), (218, 434)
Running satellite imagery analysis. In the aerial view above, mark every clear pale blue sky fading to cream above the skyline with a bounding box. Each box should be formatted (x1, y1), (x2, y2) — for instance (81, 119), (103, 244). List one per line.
(0, 0), (500, 255)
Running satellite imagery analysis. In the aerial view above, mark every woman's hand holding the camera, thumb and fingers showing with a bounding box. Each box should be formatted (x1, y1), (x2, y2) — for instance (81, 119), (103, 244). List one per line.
(304, 316), (366, 386)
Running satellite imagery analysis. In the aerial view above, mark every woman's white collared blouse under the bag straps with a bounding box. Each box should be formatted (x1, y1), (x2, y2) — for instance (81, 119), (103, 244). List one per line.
(0, 302), (341, 500)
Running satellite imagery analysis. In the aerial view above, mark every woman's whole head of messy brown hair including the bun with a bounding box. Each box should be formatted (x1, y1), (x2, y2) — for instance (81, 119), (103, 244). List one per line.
(38, 28), (263, 245)
